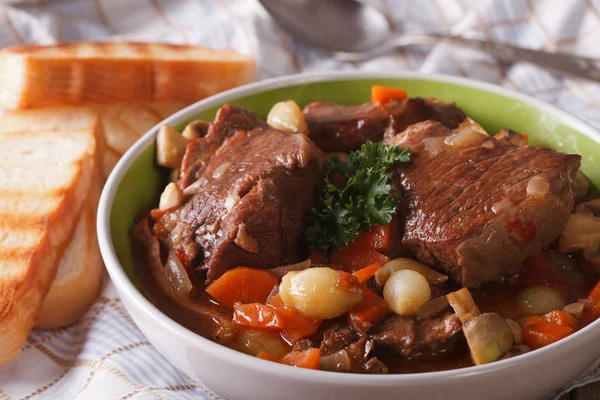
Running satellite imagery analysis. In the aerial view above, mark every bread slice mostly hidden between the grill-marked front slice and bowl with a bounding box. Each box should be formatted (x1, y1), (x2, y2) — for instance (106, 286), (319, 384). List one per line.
(35, 170), (104, 329)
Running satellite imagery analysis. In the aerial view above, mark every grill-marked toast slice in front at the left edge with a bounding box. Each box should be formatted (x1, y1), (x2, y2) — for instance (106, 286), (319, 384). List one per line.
(0, 109), (100, 364)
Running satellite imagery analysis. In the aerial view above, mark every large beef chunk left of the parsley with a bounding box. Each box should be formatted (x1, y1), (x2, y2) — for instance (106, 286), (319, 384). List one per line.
(155, 104), (322, 282)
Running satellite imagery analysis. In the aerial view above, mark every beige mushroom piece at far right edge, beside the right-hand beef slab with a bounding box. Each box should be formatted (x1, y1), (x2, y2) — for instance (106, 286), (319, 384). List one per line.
(558, 199), (600, 264)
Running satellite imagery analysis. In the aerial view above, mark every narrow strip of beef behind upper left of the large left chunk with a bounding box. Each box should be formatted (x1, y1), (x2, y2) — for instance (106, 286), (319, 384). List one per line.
(181, 104), (266, 188)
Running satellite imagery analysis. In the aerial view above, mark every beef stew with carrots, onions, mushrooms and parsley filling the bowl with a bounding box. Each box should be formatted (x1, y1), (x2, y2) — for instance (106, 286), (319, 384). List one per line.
(132, 86), (600, 374)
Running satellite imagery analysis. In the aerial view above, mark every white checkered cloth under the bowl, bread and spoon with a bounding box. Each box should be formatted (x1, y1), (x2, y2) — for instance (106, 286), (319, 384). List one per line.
(0, 0), (600, 400)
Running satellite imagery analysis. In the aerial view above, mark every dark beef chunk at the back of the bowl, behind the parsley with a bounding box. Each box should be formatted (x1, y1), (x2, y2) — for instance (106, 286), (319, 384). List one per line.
(303, 97), (466, 151)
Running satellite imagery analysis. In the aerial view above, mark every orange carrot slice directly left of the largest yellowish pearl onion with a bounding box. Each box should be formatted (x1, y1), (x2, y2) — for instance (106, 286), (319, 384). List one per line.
(206, 267), (277, 307)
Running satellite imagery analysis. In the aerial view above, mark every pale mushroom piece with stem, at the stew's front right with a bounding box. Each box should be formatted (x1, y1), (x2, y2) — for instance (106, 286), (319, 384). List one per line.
(447, 288), (514, 365)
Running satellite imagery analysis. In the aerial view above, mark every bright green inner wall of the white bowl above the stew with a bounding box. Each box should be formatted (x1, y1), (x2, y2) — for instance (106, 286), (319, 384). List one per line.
(111, 79), (600, 284)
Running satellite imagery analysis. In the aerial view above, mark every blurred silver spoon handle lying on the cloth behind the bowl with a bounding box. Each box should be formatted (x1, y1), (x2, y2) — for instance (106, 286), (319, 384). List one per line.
(335, 34), (600, 81)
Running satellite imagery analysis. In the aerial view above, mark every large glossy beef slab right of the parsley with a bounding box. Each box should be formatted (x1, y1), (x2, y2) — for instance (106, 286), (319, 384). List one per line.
(389, 121), (581, 287)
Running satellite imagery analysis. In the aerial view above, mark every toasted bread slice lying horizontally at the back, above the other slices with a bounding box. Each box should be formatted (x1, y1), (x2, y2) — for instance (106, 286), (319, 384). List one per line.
(0, 42), (255, 109)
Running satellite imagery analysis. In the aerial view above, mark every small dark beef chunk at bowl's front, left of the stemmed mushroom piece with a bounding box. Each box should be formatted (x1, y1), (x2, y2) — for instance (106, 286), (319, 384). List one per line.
(369, 310), (462, 358)
